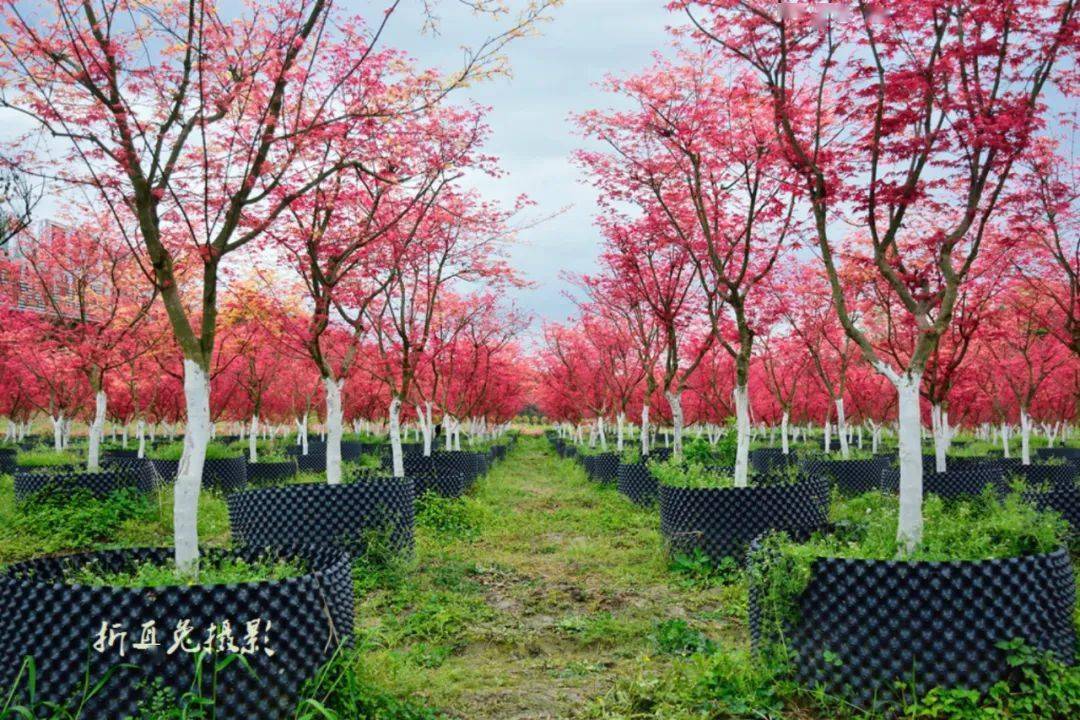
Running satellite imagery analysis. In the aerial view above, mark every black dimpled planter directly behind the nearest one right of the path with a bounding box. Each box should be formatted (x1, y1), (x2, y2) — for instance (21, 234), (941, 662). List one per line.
(660, 477), (828, 561)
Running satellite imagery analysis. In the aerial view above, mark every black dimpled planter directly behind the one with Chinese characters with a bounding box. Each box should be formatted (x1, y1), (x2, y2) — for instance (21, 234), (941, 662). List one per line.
(227, 478), (415, 554)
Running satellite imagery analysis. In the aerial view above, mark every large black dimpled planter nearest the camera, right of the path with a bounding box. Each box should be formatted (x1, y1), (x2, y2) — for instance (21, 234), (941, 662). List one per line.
(750, 549), (1076, 707)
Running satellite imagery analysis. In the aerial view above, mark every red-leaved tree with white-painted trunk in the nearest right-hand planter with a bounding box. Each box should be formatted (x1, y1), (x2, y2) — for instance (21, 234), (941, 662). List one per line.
(670, 0), (1077, 552)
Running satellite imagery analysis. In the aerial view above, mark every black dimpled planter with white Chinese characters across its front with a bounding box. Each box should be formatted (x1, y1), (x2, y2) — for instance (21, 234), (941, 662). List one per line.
(0, 549), (353, 720)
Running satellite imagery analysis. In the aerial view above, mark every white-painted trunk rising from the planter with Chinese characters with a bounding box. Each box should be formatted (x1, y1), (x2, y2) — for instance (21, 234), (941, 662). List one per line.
(173, 359), (211, 574)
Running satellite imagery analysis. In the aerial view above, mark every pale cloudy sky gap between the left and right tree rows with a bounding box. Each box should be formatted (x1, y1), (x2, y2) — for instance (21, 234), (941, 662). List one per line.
(367, 0), (678, 326)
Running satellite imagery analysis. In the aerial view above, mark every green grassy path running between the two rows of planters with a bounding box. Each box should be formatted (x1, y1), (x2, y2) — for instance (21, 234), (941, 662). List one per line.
(357, 438), (744, 720)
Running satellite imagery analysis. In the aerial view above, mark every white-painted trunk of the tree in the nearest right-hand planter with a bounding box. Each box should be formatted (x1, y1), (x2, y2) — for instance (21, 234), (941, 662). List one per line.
(890, 373), (922, 554)
